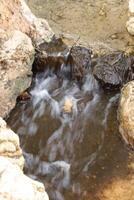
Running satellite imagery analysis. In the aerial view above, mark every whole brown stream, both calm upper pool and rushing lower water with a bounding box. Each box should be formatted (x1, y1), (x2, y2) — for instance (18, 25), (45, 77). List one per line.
(7, 0), (133, 200)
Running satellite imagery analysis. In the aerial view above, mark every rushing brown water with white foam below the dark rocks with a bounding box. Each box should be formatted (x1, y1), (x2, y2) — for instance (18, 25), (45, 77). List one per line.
(8, 61), (133, 200)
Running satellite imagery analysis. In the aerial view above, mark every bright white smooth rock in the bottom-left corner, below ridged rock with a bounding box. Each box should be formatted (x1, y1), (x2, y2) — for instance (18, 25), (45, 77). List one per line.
(0, 156), (49, 200)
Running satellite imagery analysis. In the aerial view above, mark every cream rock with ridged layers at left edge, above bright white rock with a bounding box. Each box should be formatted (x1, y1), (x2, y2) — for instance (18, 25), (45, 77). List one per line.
(0, 117), (24, 169)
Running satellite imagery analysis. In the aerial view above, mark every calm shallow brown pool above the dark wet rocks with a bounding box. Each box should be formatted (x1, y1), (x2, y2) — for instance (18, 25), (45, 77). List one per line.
(27, 0), (133, 50)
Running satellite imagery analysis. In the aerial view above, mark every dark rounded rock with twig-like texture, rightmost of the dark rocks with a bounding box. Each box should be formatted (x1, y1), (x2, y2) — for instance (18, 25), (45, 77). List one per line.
(93, 52), (129, 89)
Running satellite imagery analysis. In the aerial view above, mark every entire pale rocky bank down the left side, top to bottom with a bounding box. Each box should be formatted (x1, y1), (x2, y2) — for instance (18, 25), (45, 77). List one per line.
(0, 0), (54, 200)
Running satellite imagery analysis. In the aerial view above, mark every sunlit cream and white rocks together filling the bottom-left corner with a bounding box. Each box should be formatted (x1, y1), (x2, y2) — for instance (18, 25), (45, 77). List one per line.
(0, 117), (48, 200)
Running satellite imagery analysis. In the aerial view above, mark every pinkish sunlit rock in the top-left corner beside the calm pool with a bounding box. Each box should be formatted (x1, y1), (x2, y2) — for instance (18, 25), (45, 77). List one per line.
(0, 0), (53, 44)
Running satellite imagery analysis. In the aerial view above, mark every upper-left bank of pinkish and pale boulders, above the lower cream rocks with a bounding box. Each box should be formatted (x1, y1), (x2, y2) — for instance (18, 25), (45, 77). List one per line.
(0, 0), (54, 117)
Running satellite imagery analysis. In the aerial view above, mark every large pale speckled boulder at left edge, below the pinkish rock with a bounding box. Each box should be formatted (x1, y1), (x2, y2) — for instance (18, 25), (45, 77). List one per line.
(0, 31), (35, 116)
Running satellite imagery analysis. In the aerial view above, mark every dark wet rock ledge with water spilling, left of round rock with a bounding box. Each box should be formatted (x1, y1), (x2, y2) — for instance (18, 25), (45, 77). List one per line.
(33, 43), (92, 84)
